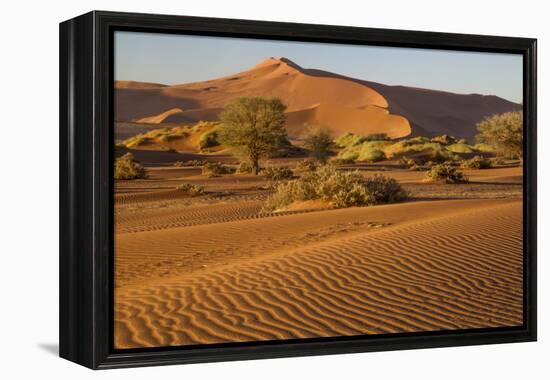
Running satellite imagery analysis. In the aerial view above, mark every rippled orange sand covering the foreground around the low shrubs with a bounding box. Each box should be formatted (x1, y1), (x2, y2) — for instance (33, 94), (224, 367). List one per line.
(115, 159), (522, 348)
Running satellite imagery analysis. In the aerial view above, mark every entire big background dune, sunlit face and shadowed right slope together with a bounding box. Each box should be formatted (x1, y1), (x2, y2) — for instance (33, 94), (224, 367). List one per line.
(115, 58), (521, 138)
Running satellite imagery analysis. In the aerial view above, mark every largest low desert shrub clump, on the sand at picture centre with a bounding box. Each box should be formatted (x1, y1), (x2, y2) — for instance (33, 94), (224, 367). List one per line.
(264, 166), (407, 211)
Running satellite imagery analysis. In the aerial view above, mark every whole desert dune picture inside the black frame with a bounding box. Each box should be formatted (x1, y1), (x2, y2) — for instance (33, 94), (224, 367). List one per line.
(112, 31), (524, 349)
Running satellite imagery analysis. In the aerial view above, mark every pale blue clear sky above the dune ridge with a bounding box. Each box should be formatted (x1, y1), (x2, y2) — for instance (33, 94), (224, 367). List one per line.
(114, 31), (523, 103)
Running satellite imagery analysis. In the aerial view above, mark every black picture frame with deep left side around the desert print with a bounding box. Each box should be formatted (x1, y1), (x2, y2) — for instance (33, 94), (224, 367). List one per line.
(59, 11), (537, 369)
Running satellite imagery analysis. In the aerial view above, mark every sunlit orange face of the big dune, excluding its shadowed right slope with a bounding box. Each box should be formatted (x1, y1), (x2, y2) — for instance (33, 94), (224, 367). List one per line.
(116, 58), (411, 138)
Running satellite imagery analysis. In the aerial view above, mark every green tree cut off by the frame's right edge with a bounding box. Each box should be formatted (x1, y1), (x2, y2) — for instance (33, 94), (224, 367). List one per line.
(476, 111), (523, 159)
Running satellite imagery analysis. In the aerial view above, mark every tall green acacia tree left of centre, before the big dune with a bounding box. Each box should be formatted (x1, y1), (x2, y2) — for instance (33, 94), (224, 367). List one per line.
(218, 97), (287, 174)
